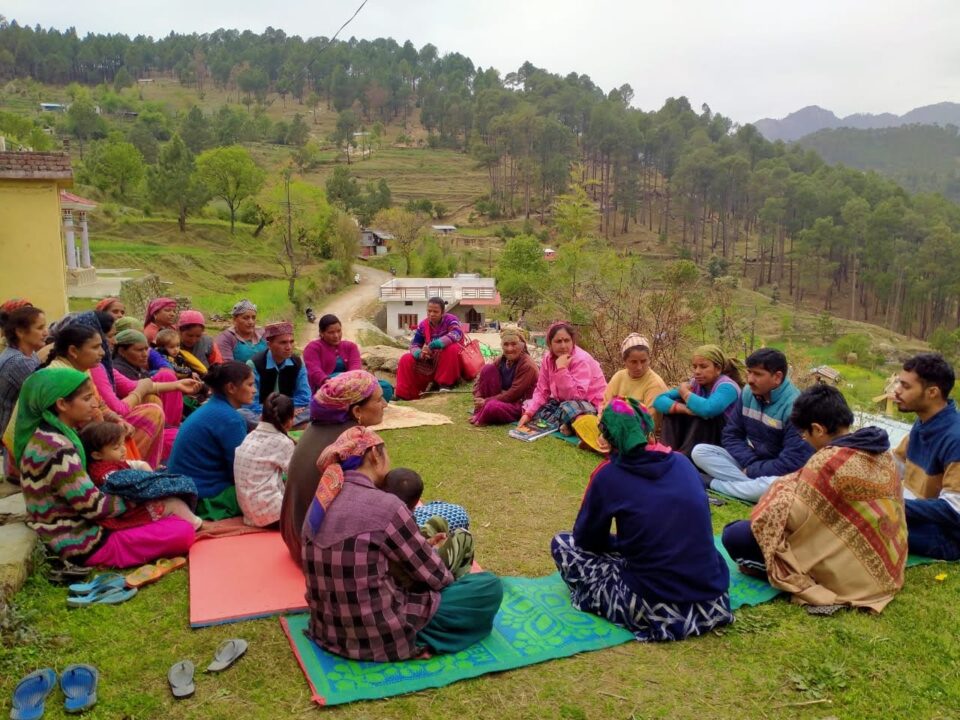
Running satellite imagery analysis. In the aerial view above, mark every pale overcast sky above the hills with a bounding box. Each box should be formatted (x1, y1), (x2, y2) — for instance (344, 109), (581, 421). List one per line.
(0, 0), (960, 122)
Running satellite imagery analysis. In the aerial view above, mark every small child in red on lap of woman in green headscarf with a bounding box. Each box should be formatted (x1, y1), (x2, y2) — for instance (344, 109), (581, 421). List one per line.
(80, 422), (203, 530)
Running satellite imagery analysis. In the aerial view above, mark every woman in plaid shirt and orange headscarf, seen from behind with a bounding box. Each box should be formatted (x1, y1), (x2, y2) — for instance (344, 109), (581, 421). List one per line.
(302, 427), (503, 662)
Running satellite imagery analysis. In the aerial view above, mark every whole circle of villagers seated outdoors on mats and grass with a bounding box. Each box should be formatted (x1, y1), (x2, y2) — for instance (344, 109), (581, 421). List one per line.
(0, 290), (960, 661)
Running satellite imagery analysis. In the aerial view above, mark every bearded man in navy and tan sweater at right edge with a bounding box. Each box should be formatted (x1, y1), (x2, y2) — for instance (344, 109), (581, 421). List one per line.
(894, 353), (960, 560)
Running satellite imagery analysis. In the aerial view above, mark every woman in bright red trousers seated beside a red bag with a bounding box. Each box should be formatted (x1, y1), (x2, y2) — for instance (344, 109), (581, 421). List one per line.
(397, 297), (463, 400)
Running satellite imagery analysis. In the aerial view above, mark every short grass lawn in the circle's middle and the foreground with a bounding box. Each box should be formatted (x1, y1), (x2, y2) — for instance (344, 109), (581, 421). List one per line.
(0, 395), (960, 720)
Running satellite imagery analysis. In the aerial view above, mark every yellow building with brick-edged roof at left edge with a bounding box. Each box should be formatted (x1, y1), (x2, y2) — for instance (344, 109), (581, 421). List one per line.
(0, 152), (74, 320)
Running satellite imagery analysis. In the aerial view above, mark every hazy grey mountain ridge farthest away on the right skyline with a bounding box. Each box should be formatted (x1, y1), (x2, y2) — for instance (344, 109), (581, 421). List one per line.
(753, 102), (960, 142)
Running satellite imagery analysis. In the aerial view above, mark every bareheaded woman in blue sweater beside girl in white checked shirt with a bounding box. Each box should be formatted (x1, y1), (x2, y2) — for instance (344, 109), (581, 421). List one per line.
(167, 361), (257, 520)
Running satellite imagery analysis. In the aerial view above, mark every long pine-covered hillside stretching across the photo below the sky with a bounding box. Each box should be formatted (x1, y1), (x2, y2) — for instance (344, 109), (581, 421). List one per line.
(0, 21), (960, 337)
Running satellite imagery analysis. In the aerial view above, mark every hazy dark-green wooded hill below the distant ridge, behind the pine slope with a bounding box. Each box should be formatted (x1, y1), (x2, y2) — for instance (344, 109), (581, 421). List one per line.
(798, 125), (960, 202)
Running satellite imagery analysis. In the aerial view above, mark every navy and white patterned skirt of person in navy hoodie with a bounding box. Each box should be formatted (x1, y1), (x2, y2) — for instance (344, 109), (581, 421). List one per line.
(550, 533), (733, 642)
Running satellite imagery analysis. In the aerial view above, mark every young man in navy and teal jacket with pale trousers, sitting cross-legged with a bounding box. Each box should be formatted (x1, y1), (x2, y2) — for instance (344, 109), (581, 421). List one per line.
(690, 348), (813, 502)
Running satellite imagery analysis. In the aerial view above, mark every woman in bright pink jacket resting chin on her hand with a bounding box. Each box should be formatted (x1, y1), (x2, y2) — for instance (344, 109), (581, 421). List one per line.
(519, 321), (607, 435)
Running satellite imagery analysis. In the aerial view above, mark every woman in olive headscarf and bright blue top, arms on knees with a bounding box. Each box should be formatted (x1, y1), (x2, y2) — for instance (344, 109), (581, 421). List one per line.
(653, 345), (743, 457)
